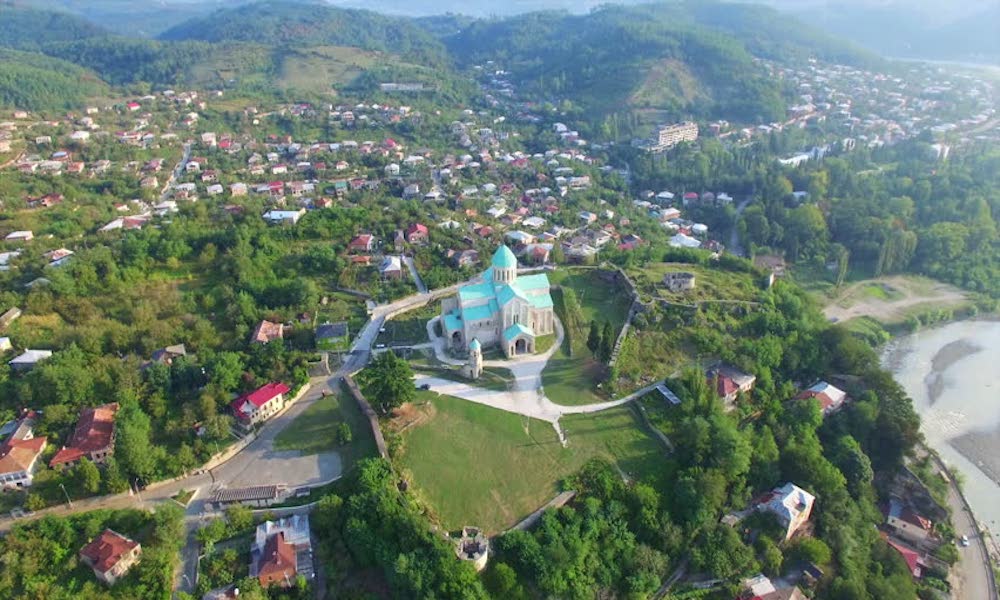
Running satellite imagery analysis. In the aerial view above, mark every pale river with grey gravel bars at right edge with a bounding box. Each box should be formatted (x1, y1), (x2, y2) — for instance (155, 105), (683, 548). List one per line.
(882, 321), (1000, 537)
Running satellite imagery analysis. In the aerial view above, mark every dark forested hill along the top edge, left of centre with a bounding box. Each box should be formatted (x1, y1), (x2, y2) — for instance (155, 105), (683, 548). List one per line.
(160, 1), (447, 66)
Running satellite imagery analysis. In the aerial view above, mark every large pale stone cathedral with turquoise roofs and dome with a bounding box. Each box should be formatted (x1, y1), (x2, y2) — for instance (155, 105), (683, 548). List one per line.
(441, 246), (555, 358)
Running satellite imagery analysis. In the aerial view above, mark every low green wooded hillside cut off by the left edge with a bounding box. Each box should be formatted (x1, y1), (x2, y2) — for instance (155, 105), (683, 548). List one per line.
(0, 49), (108, 110)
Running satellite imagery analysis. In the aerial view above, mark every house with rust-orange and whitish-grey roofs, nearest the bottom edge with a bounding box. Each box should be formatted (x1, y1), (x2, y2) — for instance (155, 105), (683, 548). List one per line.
(250, 515), (313, 587)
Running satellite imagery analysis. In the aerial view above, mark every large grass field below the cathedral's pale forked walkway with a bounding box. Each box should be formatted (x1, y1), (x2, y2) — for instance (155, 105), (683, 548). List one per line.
(401, 392), (672, 533)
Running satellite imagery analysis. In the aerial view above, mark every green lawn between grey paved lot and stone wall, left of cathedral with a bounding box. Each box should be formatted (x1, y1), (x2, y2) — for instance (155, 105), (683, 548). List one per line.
(274, 391), (376, 471)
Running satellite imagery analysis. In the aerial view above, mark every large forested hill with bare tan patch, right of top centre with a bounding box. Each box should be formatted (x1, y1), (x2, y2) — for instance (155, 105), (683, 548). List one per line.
(446, 6), (784, 122)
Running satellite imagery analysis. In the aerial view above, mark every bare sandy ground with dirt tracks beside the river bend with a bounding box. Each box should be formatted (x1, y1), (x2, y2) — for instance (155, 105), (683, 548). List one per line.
(823, 276), (966, 323)
